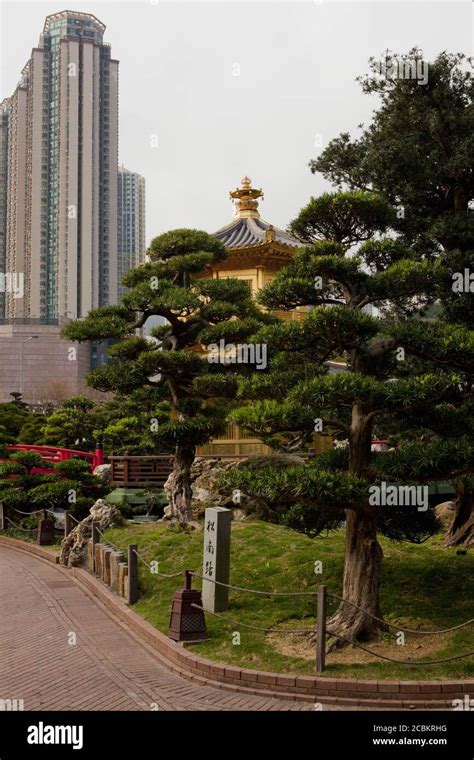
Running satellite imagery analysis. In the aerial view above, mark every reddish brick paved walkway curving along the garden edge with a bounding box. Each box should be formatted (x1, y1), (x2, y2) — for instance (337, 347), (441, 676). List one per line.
(0, 546), (314, 711)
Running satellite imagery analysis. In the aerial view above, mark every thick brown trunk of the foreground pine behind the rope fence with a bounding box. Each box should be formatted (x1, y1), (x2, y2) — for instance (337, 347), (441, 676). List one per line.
(327, 404), (386, 650)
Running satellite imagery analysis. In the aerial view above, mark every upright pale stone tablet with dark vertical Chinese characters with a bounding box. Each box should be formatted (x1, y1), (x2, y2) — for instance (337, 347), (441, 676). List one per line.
(202, 507), (232, 612)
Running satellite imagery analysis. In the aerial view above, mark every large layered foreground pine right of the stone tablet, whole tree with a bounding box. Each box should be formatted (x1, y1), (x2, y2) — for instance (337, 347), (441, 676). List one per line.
(228, 191), (474, 639)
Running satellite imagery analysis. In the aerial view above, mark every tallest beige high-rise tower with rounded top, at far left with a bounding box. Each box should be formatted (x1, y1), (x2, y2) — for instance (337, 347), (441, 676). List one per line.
(0, 11), (118, 321)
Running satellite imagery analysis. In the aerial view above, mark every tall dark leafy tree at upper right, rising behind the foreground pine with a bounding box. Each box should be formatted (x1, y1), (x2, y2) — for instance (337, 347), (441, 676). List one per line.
(310, 48), (474, 545)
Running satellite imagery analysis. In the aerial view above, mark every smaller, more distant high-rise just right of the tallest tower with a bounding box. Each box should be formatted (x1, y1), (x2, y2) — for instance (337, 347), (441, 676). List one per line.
(117, 166), (146, 298)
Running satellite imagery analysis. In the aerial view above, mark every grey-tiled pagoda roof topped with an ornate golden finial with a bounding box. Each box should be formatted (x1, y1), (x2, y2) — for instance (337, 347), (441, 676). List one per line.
(213, 177), (301, 248)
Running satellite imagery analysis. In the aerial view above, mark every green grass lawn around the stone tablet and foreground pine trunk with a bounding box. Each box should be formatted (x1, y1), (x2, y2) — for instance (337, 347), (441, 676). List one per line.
(106, 521), (474, 680)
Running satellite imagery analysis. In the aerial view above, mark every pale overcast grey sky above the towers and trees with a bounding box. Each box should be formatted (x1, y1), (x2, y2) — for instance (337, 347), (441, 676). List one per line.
(0, 0), (473, 241)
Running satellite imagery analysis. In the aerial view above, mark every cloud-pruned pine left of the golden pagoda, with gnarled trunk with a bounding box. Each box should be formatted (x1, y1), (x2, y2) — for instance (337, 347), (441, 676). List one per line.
(65, 229), (272, 525)
